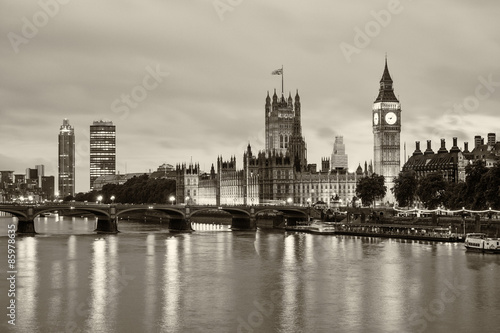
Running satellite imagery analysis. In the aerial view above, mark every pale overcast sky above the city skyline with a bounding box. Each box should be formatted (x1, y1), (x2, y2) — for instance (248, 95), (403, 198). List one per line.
(0, 0), (500, 191)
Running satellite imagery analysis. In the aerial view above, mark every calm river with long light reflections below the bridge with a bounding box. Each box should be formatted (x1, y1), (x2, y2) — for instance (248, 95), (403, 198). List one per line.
(0, 217), (500, 332)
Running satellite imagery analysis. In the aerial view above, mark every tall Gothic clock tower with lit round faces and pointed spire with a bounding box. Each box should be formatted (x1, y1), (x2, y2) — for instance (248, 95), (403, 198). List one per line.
(372, 59), (401, 203)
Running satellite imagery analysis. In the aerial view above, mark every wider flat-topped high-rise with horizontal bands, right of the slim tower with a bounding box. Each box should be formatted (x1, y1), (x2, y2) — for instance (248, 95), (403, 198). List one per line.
(90, 120), (116, 190)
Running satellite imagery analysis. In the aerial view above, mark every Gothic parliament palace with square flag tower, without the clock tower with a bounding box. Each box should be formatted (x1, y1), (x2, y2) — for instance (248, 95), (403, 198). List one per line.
(176, 92), (373, 206)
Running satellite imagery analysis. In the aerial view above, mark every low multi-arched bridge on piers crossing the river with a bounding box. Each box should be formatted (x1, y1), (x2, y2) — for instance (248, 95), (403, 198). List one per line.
(0, 203), (314, 234)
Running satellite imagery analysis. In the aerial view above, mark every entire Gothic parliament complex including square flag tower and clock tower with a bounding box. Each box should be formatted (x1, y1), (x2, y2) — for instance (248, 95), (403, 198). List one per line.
(175, 60), (401, 206)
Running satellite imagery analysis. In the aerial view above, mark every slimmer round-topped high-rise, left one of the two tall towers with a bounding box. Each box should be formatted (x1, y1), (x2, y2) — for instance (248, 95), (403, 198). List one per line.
(58, 119), (75, 198)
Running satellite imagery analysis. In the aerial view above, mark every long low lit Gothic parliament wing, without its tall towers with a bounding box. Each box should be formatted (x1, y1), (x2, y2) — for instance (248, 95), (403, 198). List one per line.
(177, 145), (372, 207)
